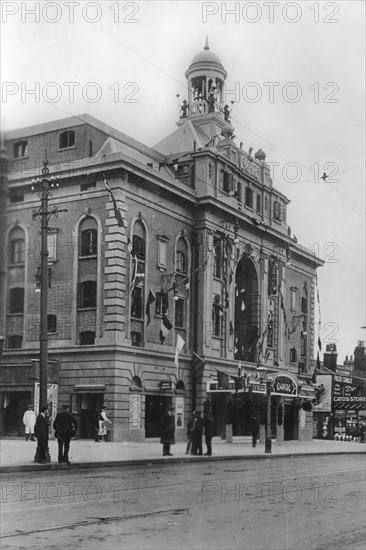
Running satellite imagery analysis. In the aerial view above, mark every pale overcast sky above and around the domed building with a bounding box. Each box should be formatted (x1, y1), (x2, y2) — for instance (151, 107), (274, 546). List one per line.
(0, 0), (366, 364)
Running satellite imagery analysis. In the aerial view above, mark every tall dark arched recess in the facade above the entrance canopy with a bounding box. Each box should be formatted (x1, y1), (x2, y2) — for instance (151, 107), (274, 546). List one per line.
(235, 256), (260, 363)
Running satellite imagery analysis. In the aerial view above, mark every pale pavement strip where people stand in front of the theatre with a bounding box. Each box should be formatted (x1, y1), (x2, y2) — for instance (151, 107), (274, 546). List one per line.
(0, 437), (366, 473)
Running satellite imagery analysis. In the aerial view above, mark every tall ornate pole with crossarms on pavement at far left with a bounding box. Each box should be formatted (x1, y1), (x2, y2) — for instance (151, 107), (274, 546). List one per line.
(32, 158), (67, 409)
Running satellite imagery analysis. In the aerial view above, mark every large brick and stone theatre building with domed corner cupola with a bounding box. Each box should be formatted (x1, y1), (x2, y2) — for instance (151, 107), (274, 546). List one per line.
(0, 43), (322, 441)
